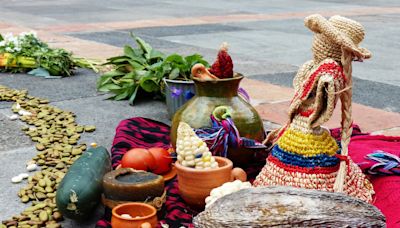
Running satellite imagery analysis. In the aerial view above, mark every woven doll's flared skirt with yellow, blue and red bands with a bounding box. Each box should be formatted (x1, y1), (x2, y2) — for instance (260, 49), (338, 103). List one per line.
(253, 128), (373, 202)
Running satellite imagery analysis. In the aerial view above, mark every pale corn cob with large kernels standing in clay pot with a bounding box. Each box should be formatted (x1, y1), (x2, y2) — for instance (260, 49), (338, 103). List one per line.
(176, 122), (218, 169)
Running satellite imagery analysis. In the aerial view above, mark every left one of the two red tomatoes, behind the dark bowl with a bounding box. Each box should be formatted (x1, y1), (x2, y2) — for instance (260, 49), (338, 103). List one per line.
(121, 148), (157, 171)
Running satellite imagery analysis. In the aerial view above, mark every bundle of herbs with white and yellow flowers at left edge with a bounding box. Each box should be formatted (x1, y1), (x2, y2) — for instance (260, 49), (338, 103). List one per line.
(0, 32), (97, 77)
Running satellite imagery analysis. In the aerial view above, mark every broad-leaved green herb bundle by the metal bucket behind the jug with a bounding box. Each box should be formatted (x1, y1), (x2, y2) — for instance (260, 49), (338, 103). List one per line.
(97, 33), (209, 105)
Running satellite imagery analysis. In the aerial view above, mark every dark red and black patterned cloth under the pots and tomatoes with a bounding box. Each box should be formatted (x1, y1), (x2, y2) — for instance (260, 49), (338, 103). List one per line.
(96, 117), (266, 228)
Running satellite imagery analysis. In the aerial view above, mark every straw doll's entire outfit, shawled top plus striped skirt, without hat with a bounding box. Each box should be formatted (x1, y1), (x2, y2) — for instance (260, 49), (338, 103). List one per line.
(253, 59), (373, 202)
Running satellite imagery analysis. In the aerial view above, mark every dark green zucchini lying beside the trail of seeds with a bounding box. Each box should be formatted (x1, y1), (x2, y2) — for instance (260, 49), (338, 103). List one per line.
(56, 147), (111, 220)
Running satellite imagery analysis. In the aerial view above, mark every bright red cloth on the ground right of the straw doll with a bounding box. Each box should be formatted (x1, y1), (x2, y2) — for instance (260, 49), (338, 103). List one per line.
(331, 125), (400, 228)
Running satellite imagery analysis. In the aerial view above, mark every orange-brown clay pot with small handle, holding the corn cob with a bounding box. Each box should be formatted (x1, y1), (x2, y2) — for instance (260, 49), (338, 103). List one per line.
(175, 156), (247, 209)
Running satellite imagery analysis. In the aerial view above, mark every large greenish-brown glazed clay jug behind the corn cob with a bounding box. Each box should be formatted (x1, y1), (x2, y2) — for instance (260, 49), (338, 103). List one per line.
(171, 68), (264, 167)
